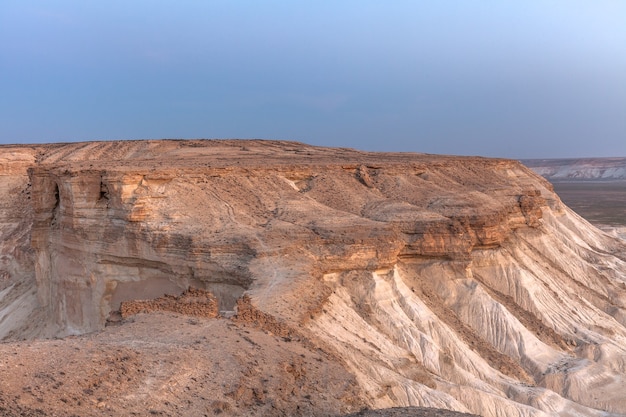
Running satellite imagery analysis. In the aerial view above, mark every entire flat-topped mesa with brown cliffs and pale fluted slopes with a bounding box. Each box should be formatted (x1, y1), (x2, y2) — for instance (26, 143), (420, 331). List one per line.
(0, 141), (626, 416)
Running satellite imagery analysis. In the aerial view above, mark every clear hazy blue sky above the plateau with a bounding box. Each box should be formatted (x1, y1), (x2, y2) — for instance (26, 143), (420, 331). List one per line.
(0, 0), (626, 158)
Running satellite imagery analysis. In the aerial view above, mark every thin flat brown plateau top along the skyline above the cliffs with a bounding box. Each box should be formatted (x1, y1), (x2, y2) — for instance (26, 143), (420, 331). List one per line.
(0, 139), (505, 170)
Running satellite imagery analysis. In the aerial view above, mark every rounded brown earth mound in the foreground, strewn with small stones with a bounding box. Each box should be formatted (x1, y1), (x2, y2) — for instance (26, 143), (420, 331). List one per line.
(0, 312), (362, 417)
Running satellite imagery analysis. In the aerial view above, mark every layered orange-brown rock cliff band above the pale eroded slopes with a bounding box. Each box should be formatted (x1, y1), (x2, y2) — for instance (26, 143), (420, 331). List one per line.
(29, 142), (545, 333)
